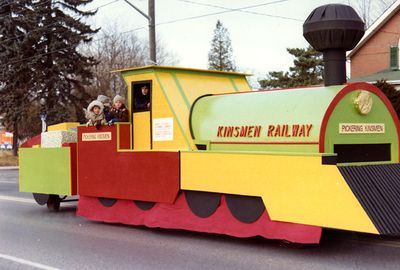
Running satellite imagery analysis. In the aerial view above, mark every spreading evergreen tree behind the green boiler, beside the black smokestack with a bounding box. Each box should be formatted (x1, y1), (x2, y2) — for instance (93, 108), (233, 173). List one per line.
(259, 46), (323, 89)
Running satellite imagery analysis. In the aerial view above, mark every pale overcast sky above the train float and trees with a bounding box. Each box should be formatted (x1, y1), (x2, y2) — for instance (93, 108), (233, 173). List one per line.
(86, 0), (386, 79)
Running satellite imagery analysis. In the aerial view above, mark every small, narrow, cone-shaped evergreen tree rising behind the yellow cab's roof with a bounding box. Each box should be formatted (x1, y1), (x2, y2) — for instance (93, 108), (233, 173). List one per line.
(208, 20), (236, 71)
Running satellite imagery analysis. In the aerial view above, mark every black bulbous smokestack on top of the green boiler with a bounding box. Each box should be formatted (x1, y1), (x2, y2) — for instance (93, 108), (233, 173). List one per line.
(303, 4), (365, 86)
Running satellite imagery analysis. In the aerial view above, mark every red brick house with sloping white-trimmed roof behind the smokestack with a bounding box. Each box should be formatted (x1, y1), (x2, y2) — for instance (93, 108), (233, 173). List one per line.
(347, 0), (400, 85)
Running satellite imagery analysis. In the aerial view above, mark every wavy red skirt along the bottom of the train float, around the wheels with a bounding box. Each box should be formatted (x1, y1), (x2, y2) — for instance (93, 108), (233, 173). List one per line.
(77, 192), (322, 244)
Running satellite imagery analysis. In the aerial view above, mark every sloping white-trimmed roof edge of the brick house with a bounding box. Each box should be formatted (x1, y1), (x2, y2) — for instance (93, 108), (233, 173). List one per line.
(347, 0), (400, 58)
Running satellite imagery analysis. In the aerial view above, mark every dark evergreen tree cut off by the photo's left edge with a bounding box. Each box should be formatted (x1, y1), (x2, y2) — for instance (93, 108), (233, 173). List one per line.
(0, 0), (34, 155)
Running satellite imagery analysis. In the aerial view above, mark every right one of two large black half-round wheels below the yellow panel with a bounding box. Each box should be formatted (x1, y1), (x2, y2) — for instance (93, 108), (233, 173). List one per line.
(225, 195), (265, 223)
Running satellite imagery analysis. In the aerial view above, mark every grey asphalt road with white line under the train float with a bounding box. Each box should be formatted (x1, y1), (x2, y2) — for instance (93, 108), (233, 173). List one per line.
(0, 169), (400, 270)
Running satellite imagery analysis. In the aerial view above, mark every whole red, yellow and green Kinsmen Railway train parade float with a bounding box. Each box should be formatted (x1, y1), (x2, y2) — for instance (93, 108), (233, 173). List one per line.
(19, 5), (400, 244)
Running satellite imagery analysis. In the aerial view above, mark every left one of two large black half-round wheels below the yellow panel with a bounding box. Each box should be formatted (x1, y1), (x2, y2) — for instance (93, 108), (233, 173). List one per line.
(185, 190), (221, 218)
